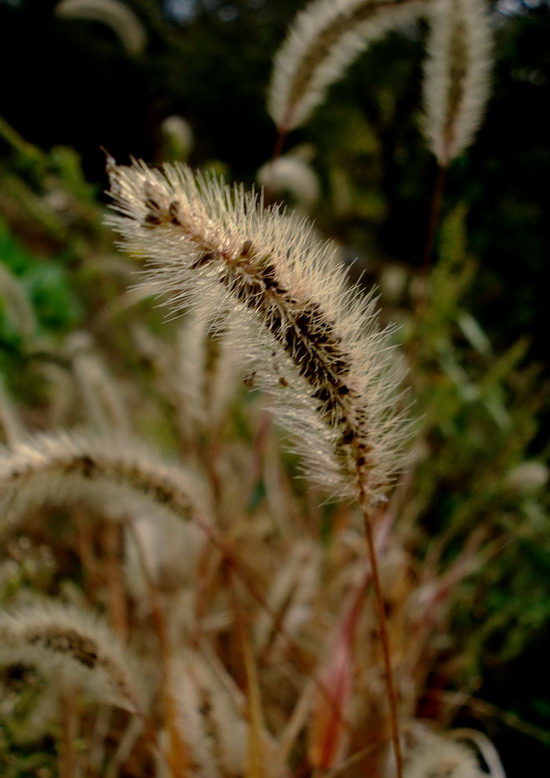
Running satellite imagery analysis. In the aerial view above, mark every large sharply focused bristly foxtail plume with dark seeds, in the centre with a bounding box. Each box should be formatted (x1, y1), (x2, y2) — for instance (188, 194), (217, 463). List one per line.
(109, 163), (407, 501)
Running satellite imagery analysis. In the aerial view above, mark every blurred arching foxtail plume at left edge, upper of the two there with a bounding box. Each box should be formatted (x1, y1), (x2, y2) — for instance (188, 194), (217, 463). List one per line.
(0, 432), (210, 521)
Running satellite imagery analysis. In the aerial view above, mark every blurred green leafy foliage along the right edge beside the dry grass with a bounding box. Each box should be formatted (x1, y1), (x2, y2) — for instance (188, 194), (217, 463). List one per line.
(404, 207), (550, 764)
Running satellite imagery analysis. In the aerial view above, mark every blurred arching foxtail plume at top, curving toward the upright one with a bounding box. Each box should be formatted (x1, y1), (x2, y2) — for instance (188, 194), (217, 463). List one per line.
(268, 0), (427, 132)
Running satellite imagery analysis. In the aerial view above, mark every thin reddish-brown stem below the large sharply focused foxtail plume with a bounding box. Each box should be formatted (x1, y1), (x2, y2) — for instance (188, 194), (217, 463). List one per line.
(359, 492), (403, 778)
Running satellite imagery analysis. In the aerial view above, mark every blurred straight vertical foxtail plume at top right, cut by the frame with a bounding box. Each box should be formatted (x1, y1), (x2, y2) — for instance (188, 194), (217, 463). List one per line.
(424, 0), (492, 167)
